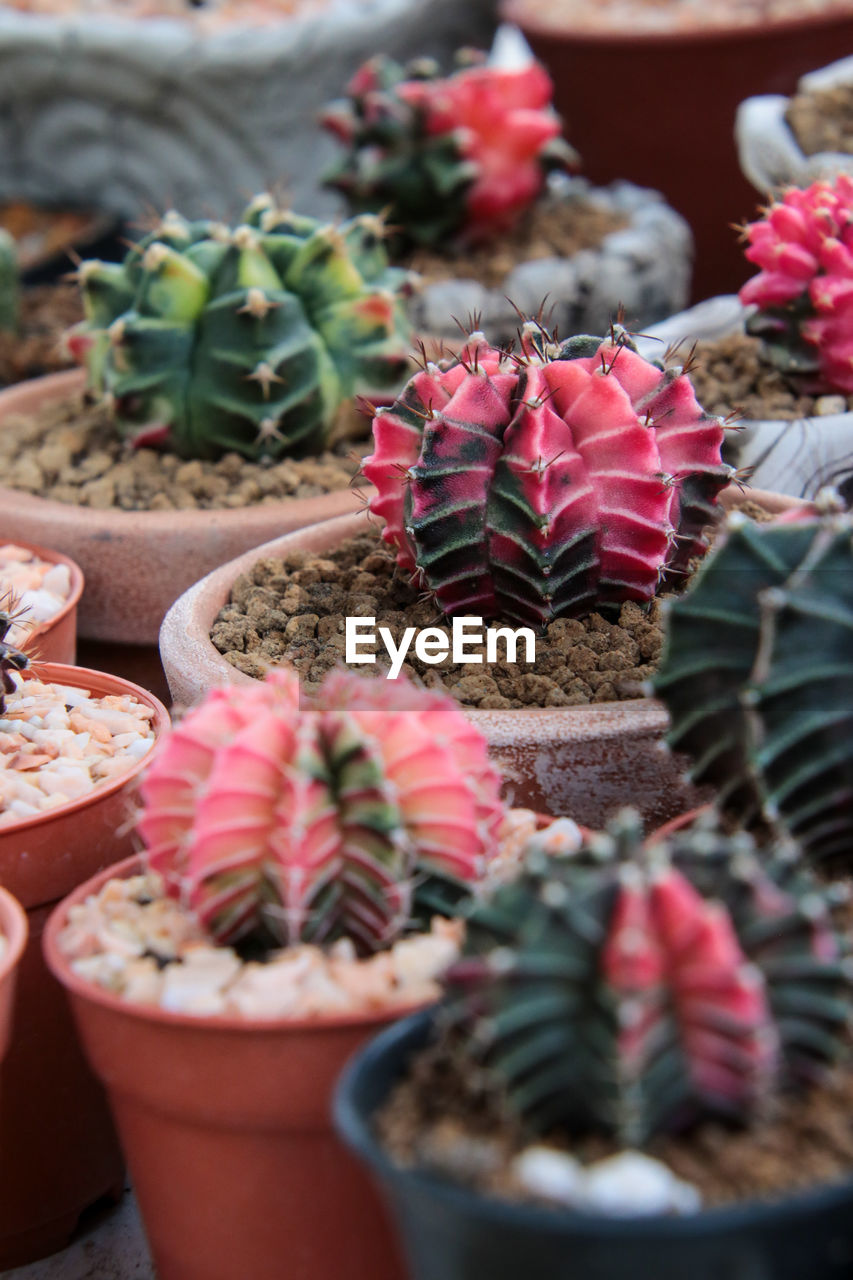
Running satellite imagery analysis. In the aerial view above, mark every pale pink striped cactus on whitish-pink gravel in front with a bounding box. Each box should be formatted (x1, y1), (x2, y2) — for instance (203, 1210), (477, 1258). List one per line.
(138, 672), (503, 951)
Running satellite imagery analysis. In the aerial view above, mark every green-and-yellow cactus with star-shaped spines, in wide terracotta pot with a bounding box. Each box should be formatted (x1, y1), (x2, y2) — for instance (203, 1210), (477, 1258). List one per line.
(69, 196), (410, 458)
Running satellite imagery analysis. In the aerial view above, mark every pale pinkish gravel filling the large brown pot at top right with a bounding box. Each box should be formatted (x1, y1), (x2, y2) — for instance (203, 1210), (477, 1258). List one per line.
(504, 0), (849, 35)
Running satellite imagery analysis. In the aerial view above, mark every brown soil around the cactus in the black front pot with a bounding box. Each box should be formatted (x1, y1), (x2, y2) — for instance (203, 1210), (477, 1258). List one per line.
(377, 1046), (853, 1207)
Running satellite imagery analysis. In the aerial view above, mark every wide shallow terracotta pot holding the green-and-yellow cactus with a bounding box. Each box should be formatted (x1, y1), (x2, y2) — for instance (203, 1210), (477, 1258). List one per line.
(0, 370), (368, 645)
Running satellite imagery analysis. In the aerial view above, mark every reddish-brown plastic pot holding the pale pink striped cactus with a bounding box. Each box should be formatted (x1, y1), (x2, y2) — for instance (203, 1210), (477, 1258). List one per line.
(45, 858), (417, 1280)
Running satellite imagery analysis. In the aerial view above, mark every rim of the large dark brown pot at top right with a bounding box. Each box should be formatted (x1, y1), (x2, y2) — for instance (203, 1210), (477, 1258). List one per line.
(498, 0), (853, 51)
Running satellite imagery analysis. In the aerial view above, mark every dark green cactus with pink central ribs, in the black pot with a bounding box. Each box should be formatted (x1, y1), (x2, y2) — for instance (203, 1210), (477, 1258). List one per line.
(443, 812), (853, 1146)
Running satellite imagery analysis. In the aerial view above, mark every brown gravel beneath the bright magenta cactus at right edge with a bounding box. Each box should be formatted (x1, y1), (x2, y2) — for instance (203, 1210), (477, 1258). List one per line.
(690, 333), (853, 420)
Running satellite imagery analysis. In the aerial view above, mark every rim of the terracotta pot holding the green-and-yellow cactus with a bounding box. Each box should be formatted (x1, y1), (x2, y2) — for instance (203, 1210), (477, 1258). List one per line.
(0, 369), (368, 539)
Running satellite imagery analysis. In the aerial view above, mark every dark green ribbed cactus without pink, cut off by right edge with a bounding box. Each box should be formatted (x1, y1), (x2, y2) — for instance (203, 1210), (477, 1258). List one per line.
(653, 504), (853, 867)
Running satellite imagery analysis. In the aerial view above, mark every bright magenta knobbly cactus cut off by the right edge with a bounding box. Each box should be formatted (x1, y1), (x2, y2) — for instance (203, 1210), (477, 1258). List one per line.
(740, 174), (853, 392)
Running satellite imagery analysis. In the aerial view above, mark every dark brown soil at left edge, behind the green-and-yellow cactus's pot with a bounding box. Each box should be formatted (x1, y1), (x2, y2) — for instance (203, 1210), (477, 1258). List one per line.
(0, 283), (83, 387)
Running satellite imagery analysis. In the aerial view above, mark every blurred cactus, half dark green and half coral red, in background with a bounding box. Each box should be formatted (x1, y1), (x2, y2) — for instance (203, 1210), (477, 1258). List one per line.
(323, 50), (576, 250)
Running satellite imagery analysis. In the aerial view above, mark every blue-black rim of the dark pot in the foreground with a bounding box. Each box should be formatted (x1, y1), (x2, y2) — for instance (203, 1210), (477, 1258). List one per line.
(333, 1009), (853, 1242)
